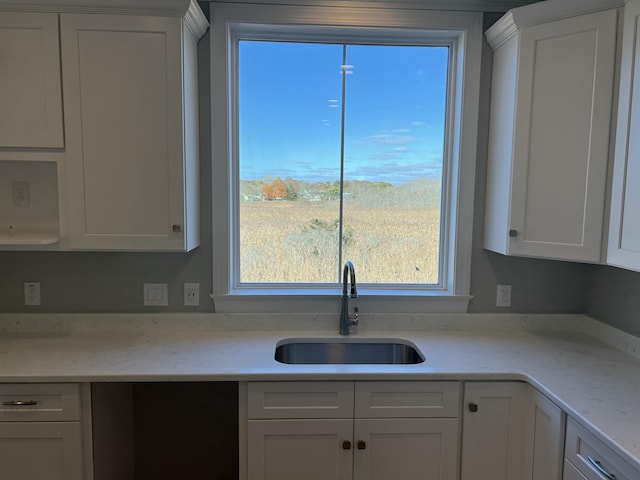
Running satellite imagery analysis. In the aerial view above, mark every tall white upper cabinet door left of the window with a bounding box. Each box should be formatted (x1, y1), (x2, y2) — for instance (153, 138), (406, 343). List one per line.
(61, 15), (190, 250)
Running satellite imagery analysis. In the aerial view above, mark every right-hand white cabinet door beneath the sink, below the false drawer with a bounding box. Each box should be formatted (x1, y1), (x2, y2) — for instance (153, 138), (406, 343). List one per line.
(353, 418), (458, 480)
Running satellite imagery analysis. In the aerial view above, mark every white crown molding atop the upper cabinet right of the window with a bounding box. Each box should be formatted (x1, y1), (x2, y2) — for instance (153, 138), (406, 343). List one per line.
(485, 0), (625, 50)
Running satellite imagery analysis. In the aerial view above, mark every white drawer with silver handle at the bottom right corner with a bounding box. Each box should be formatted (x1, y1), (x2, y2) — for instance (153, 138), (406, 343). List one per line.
(565, 418), (640, 480)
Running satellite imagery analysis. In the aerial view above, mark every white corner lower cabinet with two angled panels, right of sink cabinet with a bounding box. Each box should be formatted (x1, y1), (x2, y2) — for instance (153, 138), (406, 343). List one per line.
(461, 382), (566, 480)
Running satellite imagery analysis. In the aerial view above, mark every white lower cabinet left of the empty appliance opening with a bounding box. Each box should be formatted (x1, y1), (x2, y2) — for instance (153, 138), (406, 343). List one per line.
(0, 384), (91, 480)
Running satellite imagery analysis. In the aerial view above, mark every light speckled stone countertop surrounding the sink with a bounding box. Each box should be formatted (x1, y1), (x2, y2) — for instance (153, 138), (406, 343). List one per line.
(0, 315), (640, 471)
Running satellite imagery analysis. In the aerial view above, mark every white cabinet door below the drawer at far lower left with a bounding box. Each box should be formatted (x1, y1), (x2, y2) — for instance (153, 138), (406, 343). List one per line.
(0, 422), (83, 480)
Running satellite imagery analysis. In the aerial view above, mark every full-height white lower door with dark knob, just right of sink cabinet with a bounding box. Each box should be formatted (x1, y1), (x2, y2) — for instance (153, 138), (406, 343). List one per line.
(462, 382), (527, 480)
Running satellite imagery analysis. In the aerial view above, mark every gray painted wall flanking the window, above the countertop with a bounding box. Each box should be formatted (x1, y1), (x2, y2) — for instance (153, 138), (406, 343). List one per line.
(0, 14), (640, 332)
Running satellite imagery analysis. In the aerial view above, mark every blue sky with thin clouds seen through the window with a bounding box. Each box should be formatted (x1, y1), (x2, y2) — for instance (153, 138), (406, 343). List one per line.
(239, 41), (448, 184)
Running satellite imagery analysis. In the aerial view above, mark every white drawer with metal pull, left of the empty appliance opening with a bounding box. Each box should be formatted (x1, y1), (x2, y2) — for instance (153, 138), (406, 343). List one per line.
(0, 383), (80, 422)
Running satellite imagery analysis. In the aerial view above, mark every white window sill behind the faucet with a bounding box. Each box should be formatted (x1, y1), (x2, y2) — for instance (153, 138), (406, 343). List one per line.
(210, 289), (473, 313)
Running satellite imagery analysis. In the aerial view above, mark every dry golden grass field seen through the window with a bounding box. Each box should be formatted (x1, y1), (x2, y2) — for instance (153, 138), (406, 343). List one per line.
(240, 200), (440, 283)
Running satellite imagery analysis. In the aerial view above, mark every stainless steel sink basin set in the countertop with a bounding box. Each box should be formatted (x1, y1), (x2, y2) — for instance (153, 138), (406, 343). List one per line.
(275, 338), (424, 365)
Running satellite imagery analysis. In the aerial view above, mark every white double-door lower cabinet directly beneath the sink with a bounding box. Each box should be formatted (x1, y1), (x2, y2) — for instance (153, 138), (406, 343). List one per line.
(241, 382), (460, 480)
